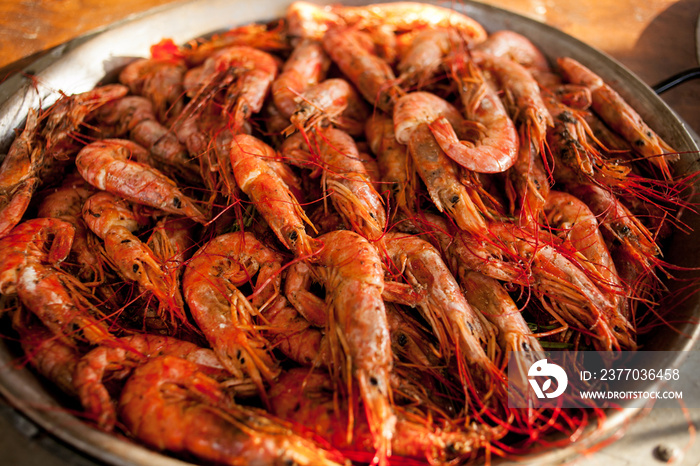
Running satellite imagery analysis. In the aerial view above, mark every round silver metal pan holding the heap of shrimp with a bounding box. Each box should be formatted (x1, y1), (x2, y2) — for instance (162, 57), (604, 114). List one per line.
(0, 0), (700, 466)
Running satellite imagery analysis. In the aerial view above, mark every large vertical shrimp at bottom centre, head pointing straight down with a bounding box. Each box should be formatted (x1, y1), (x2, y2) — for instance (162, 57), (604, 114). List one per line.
(292, 230), (396, 463)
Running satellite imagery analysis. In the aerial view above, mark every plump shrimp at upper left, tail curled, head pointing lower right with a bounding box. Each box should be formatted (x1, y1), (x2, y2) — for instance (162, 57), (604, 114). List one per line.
(75, 139), (206, 223)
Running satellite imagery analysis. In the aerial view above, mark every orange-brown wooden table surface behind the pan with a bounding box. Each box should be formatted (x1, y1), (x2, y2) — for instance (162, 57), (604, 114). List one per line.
(0, 0), (700, 132)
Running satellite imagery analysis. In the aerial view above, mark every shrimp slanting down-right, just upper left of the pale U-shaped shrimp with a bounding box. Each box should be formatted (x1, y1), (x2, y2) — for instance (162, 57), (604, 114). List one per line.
(323, 27), (399, 112)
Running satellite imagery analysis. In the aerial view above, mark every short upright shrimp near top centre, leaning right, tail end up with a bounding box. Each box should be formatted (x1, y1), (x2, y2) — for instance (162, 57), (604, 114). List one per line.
(272, 39), (331, 118)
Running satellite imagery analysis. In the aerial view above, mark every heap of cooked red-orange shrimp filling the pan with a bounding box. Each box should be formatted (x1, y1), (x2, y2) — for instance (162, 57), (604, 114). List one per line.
(0, 2), (691, 465)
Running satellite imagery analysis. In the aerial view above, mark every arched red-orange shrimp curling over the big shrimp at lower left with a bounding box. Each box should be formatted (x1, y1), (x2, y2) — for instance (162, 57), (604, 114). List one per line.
(73, 334), (225, 432)
